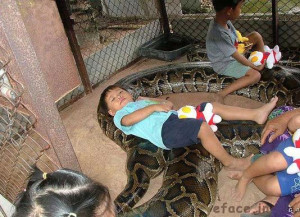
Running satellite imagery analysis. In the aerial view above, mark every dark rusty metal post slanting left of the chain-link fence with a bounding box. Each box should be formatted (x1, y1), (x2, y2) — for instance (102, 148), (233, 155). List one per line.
(56, 0), (92, 94)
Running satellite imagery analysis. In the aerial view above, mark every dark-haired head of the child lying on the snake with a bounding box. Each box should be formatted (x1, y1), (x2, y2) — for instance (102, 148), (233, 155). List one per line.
(98, 85), (133, 116)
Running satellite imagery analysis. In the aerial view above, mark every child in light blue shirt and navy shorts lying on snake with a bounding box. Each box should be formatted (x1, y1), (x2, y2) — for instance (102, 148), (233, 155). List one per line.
(99, 85), (278, 173)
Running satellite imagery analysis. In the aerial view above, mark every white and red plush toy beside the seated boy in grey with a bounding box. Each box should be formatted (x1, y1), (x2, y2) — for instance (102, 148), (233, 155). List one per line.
(249, 45), (281, 69)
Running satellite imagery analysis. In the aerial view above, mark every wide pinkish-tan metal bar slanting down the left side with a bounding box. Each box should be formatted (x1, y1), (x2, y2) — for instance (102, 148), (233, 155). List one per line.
(0, 0), (81, 171)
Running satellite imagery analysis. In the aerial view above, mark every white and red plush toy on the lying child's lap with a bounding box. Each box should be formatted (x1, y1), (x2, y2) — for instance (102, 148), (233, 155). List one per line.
(177, 103), (222, 132)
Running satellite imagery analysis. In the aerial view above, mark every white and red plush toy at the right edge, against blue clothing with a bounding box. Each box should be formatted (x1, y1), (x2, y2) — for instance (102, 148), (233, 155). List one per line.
(284, 129), (300, 176)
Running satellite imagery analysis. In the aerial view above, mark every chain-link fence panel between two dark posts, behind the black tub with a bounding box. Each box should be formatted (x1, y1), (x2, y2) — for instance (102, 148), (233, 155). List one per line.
(67, 0), (161, 86)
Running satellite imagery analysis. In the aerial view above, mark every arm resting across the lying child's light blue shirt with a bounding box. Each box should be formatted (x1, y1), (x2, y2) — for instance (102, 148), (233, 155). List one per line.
(121, 104), (172, 126)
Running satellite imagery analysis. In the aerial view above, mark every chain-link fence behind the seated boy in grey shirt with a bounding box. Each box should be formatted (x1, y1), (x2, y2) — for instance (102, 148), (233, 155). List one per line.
(167, 0), (300, 63)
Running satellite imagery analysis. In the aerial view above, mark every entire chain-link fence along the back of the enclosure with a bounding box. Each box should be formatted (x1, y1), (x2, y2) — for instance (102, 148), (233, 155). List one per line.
(58, 0), (300, 107)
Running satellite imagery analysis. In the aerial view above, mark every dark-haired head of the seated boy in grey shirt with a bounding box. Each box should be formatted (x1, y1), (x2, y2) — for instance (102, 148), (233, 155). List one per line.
(212, 0), (244, 19)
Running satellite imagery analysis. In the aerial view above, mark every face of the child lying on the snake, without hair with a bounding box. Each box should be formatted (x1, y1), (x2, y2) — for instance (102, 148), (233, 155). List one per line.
(105, 87), (133, 116)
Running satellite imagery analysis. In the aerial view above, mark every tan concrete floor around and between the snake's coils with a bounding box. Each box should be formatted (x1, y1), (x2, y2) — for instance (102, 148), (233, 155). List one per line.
(61, 57), (264, 217)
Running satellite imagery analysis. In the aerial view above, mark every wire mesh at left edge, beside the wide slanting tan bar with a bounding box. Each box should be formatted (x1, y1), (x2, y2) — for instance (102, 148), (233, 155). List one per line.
(0, 47), (58, 205)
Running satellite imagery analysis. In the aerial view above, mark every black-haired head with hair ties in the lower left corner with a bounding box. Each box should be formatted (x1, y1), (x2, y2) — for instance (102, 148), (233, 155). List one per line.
(13, 168), (115, 217)
